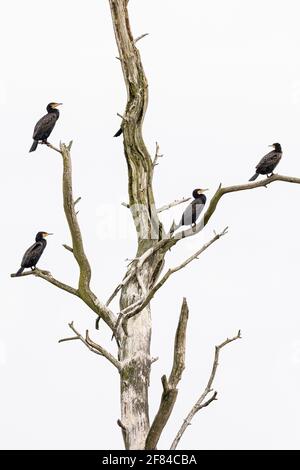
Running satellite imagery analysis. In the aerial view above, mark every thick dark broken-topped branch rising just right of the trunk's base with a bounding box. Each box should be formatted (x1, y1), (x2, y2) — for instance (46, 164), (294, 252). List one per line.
(145, 298), (189, 450)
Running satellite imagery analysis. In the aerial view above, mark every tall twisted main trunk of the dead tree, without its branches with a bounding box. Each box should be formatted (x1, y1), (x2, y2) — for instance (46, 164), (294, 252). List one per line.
(110, 0), (162, 449)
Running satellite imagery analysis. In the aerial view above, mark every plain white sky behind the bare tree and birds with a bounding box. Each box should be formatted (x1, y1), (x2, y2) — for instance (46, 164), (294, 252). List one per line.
(0, 0), (300, 449)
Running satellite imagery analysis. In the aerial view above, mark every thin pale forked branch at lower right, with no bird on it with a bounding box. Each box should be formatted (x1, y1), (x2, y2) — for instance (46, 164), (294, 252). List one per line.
(170, 330), (241, 450)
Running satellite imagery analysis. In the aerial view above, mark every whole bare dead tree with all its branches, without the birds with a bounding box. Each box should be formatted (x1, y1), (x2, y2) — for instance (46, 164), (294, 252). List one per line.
(12, 0), (300, 449)
